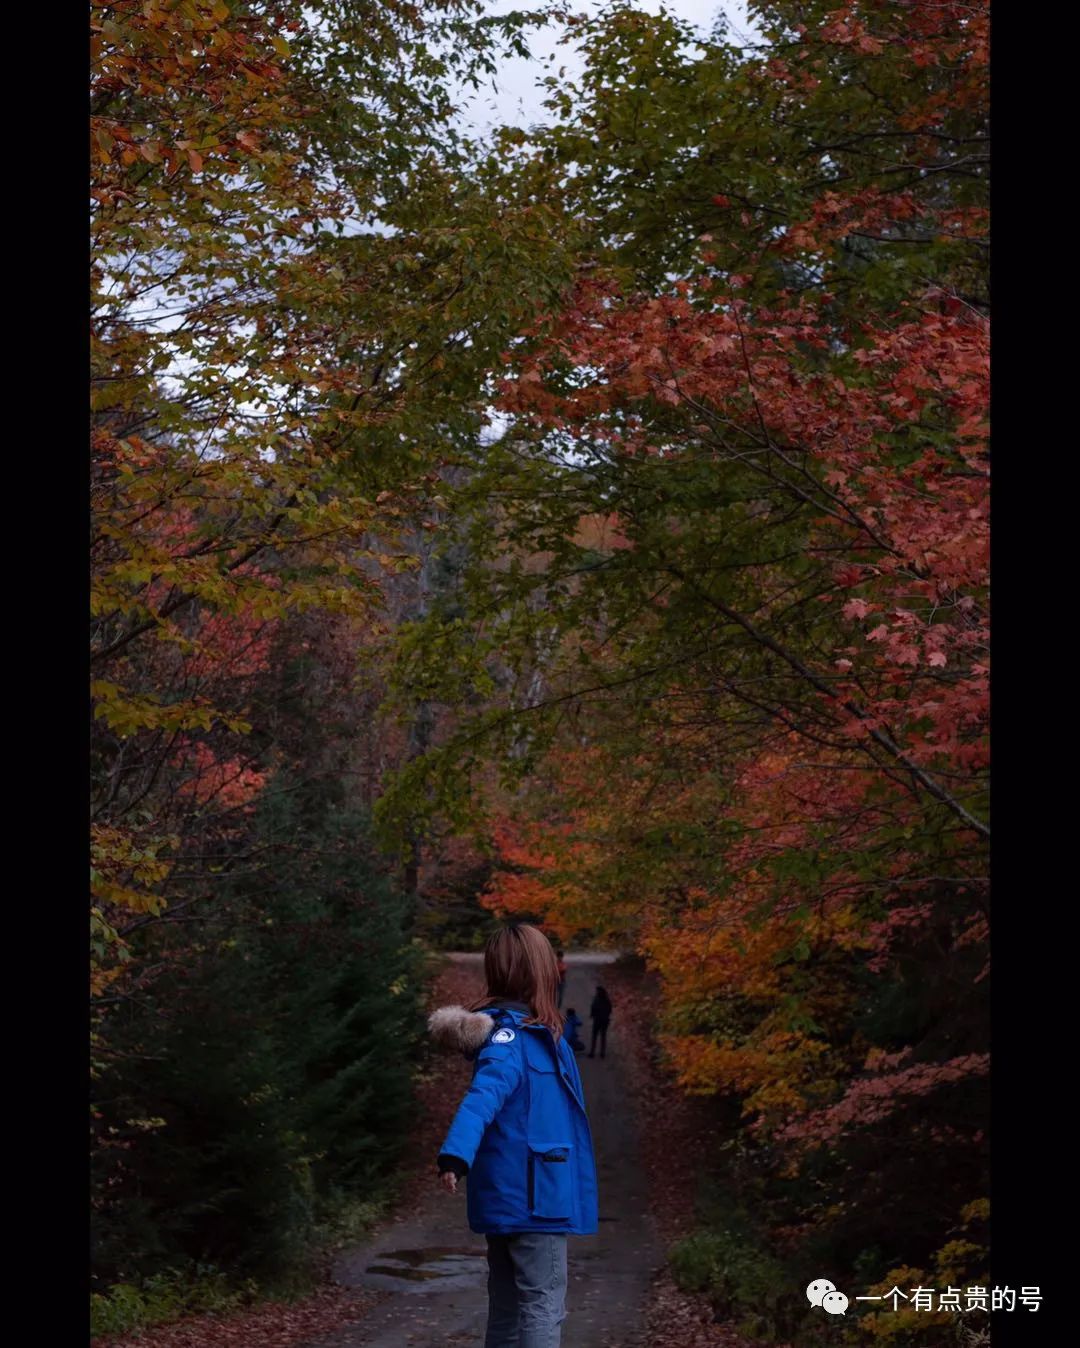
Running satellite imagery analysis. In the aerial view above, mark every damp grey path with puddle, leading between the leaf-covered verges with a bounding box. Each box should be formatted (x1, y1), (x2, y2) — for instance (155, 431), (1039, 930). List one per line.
(303, 954), (659, 1348)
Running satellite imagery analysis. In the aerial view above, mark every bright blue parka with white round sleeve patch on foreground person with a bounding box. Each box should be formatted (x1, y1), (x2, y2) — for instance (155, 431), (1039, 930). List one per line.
(440, 1004), (596, 1236)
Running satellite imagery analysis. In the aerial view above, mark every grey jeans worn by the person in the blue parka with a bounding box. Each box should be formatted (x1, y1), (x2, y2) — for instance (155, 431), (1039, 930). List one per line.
(484, 1231), (566, 1348)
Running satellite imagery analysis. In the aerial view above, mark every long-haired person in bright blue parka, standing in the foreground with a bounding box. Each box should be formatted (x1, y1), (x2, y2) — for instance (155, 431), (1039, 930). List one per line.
(430, 923), (596, 1348)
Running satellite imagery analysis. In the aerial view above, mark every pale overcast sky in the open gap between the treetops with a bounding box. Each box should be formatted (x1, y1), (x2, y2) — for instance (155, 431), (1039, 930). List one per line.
(462, 0), (754, 131)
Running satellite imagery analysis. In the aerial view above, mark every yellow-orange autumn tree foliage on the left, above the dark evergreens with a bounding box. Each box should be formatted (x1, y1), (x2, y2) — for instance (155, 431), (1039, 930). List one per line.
(90, 0), (571, 981)
